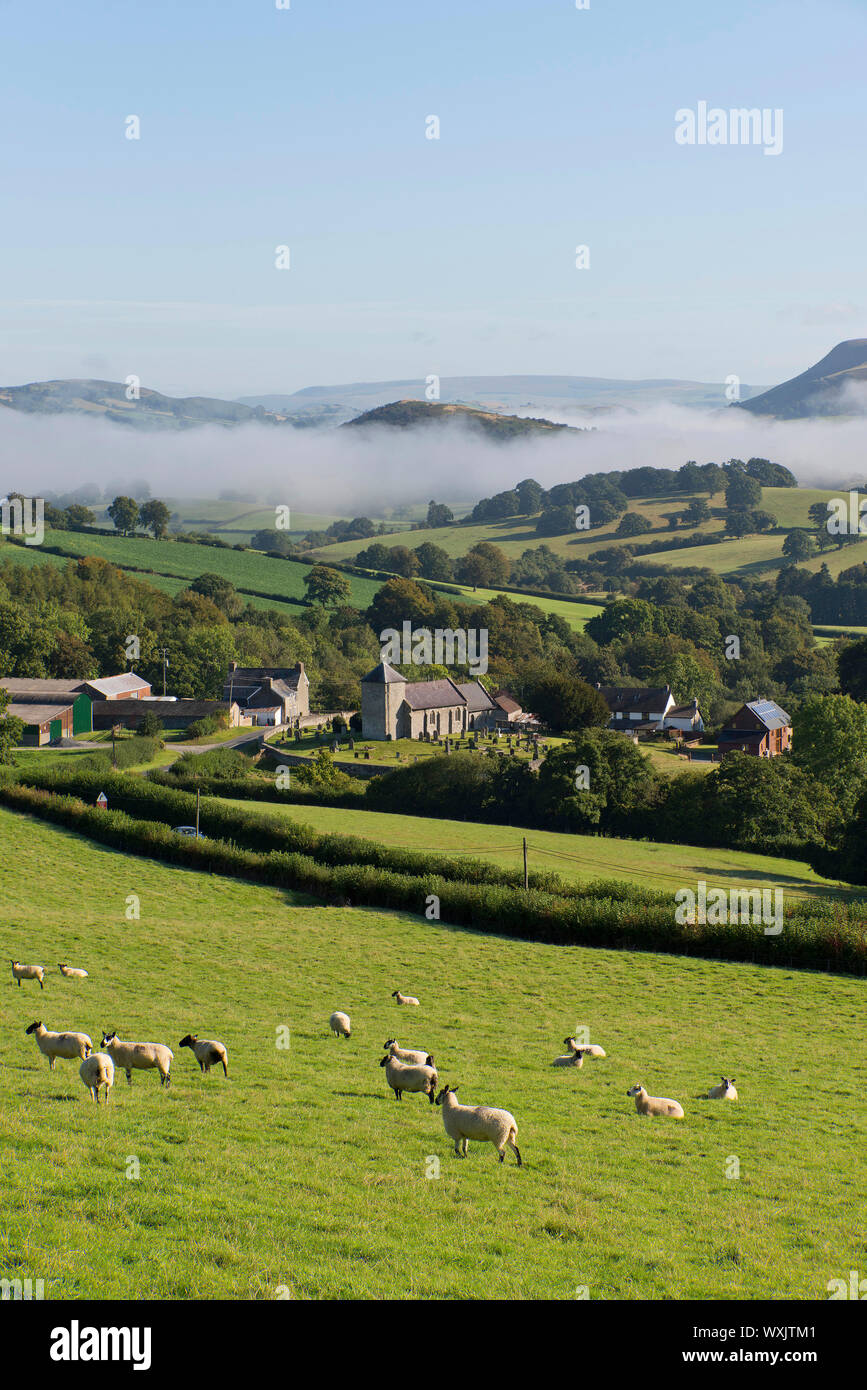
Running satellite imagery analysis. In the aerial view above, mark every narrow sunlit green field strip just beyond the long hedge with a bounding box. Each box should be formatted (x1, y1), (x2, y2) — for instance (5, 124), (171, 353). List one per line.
(218, 799), (844, 899)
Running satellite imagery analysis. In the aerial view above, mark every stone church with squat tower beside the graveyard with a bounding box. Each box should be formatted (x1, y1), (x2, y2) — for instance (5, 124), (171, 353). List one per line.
(361, 662), (521, 738)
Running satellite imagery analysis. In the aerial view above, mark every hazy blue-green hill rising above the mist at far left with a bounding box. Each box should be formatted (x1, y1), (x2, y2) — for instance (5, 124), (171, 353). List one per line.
(0, 379), (286, 430)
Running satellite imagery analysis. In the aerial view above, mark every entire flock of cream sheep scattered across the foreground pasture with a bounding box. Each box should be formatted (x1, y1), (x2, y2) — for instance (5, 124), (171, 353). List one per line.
(13, 960), (738, 1168)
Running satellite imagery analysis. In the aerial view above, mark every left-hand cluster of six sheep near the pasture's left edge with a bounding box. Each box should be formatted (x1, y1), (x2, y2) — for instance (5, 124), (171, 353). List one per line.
(13, 960), (229, 1105)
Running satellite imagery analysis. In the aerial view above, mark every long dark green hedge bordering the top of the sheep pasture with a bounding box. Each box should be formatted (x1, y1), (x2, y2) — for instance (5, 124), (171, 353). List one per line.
(0, 783), (867, 974)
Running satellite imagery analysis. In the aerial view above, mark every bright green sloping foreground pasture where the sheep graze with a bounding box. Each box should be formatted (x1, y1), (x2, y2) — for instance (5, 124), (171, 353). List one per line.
(0, 810), (867, 1300)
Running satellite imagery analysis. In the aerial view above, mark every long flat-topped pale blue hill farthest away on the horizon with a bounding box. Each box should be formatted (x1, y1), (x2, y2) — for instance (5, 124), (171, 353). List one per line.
(239, 375), (764, 424)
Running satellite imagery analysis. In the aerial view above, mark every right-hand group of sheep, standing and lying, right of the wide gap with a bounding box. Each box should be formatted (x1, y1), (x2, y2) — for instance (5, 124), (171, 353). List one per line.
(328, 990), (738, 1168)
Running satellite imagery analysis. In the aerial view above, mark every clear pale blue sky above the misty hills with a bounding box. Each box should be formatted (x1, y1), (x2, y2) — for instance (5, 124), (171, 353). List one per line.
(0, 0), (867, 395)
